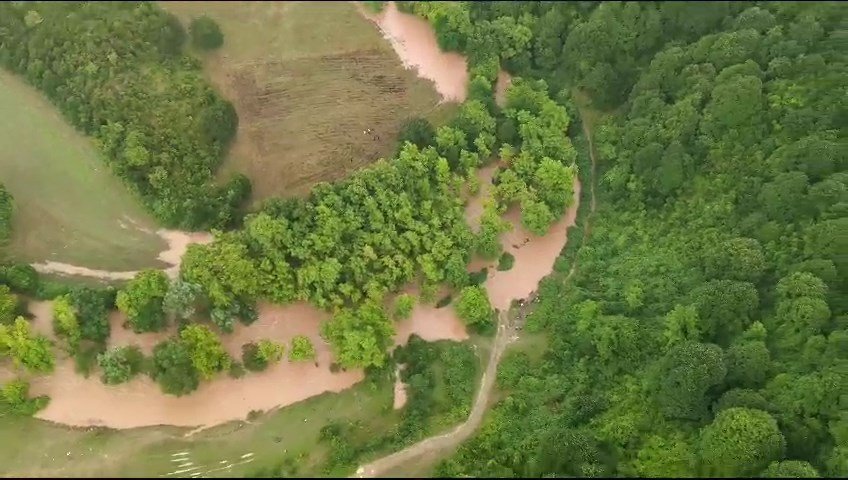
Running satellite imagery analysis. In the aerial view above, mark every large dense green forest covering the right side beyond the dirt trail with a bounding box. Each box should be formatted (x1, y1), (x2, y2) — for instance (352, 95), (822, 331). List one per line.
(401, 2), (848, 477)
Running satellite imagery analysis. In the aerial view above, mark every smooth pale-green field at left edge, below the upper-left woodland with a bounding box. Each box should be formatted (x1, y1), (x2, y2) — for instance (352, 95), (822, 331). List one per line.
(0, 71), (166, 270)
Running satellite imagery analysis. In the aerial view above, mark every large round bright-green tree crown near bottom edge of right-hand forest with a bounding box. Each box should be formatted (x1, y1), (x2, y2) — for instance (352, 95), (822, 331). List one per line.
(700, 408), (786, 477)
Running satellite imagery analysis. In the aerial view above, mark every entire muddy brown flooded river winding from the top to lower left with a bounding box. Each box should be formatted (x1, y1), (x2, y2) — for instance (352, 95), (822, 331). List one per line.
(13, 3), (580, 428)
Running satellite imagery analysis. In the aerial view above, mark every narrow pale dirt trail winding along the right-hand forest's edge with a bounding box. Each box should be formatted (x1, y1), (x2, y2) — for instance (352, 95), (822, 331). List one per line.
(350, 107), (596, 478)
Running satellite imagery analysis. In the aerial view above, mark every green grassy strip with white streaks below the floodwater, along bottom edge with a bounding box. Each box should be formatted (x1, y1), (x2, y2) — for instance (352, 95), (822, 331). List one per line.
(0, 383), (397, 477)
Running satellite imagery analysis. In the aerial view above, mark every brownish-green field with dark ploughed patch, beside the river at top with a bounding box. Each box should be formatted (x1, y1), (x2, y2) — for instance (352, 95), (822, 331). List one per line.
(161, 2), (455, 204)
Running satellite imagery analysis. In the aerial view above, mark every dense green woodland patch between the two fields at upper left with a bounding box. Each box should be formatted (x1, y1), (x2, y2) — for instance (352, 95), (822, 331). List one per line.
(0, 2), (250, 228)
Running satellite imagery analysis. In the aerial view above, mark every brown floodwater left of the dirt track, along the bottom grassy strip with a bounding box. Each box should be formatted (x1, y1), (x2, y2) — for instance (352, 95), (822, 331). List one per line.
(24, 296), (467, 428)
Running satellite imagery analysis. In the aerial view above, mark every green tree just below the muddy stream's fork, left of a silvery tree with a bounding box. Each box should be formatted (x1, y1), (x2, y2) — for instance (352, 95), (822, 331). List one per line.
(115, 270), (168, 333)
